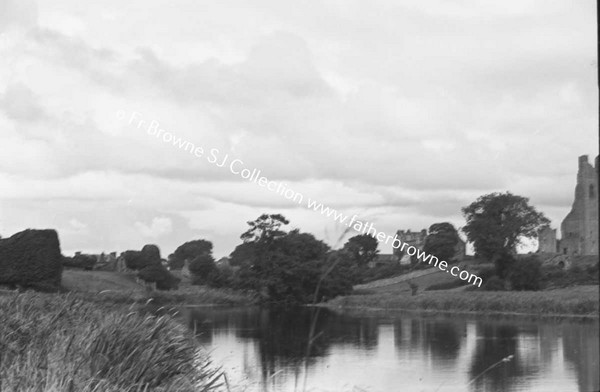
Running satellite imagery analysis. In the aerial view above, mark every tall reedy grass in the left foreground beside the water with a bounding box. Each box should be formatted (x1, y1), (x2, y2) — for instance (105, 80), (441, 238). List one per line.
(0, 293), (221, 392)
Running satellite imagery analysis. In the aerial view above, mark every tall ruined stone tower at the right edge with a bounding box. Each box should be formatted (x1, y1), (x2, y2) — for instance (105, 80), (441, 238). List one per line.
(558, 155), (599, 255)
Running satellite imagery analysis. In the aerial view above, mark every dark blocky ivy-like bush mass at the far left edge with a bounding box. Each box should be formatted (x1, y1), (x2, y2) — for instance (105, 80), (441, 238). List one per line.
(0, 229), (63, 289)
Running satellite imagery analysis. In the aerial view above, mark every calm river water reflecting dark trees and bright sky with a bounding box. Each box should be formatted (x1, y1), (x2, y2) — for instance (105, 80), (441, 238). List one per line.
(183, 308), (600, 392)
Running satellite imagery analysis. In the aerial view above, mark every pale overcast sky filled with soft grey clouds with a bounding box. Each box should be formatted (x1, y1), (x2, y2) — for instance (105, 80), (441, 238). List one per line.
(0, 0), (598, 256)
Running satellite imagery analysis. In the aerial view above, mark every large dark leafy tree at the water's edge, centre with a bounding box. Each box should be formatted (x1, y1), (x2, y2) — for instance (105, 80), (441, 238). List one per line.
(232, 214), (352, 305)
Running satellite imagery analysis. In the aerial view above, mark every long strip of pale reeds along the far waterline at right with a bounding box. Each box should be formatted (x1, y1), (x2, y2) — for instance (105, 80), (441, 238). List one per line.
(325, 286), (599, 318)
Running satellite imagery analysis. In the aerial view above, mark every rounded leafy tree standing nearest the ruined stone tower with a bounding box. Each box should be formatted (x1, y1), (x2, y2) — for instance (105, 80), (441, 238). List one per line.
(462, 192), (550, 262)
